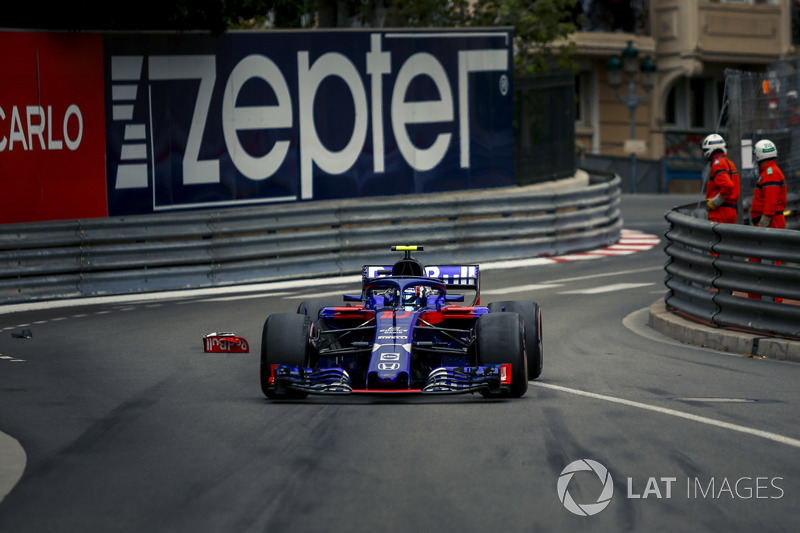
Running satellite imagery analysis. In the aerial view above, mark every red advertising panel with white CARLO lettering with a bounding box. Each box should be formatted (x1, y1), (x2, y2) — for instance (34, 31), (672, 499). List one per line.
(0, 31), (108, 223)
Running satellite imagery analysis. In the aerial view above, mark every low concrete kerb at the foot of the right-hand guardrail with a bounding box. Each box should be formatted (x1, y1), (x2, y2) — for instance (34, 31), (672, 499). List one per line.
(649, 298), (800, 363)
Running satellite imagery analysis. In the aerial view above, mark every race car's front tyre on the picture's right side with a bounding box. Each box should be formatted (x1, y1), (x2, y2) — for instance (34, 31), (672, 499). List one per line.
(475, 312), (528, 398)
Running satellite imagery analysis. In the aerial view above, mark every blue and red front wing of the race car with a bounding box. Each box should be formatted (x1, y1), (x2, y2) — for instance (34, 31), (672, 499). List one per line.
(270, 364), (512, 394)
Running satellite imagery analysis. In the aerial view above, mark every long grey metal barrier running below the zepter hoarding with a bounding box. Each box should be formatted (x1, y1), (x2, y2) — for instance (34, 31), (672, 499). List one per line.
(0, 170), (622, 303)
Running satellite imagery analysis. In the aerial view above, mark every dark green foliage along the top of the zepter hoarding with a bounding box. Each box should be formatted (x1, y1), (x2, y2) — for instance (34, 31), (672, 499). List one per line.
(0, 0), (576, 74)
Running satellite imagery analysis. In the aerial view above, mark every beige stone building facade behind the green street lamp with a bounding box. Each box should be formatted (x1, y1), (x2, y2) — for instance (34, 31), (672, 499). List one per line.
(574, 0), (798, 192)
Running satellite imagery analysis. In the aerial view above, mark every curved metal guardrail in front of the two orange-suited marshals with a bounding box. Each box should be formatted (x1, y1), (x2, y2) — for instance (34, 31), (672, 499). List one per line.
(665, 197), (800, 338)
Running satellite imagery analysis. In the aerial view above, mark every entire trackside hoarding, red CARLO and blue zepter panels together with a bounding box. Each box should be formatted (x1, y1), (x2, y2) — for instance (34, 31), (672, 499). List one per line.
(0, 29), (514, 222)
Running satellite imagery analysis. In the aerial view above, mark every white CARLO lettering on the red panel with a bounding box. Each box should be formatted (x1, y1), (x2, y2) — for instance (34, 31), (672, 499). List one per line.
(0, 104), (83, 152)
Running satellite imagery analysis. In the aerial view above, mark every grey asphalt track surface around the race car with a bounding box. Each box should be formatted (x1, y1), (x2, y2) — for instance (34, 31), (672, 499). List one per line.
(0, 195), (800, 533)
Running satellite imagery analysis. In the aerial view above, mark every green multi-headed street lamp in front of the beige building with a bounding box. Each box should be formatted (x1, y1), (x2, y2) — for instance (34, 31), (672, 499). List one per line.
(606, 41), (656, 193)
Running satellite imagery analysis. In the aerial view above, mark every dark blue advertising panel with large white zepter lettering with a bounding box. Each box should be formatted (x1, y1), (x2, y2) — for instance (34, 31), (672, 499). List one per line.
(104, 30), (514, 216)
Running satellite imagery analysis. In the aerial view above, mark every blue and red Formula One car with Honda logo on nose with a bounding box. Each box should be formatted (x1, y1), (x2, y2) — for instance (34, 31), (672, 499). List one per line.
(261, 246), (542, 399)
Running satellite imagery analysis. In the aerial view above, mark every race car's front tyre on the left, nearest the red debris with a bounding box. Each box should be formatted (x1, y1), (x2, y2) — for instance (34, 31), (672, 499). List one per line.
(261, 313), (311, 399)
